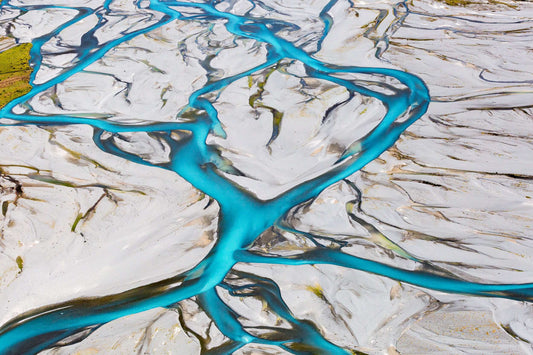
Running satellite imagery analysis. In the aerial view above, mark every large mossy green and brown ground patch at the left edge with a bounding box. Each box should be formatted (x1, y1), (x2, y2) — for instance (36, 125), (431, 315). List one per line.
(0, 43), (32, 108)
